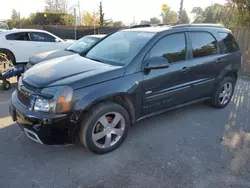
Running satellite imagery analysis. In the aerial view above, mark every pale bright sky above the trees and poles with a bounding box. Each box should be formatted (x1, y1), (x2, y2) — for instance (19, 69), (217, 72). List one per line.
(0, 0), (226, 24)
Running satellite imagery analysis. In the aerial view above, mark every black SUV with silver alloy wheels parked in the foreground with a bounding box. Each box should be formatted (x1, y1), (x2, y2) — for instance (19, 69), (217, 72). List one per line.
(10, 25), (242, 153)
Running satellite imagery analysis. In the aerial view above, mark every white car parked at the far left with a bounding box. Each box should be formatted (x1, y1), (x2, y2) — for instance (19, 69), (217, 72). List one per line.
(0, 29), (72, 65)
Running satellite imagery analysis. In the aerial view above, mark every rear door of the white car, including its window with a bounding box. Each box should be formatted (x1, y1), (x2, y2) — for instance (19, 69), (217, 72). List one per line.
(6, 32), (36, 63)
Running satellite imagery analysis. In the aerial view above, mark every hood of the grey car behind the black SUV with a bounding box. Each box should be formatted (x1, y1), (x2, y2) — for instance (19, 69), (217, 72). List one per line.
(29, 50), (75, 65)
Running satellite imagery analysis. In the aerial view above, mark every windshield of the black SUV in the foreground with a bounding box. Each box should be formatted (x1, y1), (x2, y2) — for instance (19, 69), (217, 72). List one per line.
(86, 31), (155, 65)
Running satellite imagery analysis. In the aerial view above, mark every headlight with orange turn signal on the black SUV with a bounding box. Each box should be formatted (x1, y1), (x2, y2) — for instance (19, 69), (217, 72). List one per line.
(34, 86), (73, 113)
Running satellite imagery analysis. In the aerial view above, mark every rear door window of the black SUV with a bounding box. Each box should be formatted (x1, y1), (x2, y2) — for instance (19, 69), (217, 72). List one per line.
(190, 32), (217, 58)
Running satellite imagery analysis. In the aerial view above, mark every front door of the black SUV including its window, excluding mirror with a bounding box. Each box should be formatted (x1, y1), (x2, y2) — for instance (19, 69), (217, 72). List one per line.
(143, 33), (190, 115)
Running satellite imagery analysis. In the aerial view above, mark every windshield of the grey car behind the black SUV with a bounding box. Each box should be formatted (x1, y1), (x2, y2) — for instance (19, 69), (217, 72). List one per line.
(67, 37), (100, 53)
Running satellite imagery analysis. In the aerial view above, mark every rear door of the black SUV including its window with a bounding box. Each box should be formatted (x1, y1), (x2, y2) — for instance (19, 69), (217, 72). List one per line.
(186, 31), (227, 100)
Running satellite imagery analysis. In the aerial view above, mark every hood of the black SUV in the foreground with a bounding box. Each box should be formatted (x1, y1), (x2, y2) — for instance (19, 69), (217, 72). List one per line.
(23, 54), (125, 89)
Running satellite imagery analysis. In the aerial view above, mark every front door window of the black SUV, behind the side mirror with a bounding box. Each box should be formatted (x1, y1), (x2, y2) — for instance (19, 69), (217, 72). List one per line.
(151, 33), (186, 63)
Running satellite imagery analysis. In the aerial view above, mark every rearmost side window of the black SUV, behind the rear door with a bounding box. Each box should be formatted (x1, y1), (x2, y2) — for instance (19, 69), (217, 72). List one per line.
(219, 32), (240, 53)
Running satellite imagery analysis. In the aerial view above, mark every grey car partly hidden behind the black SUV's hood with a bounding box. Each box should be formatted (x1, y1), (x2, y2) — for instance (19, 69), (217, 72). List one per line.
(25, 35), (105, 70)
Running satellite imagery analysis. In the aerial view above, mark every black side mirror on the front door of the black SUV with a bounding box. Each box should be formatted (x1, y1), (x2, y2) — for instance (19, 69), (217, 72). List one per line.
(144, 56), (170, 70)
